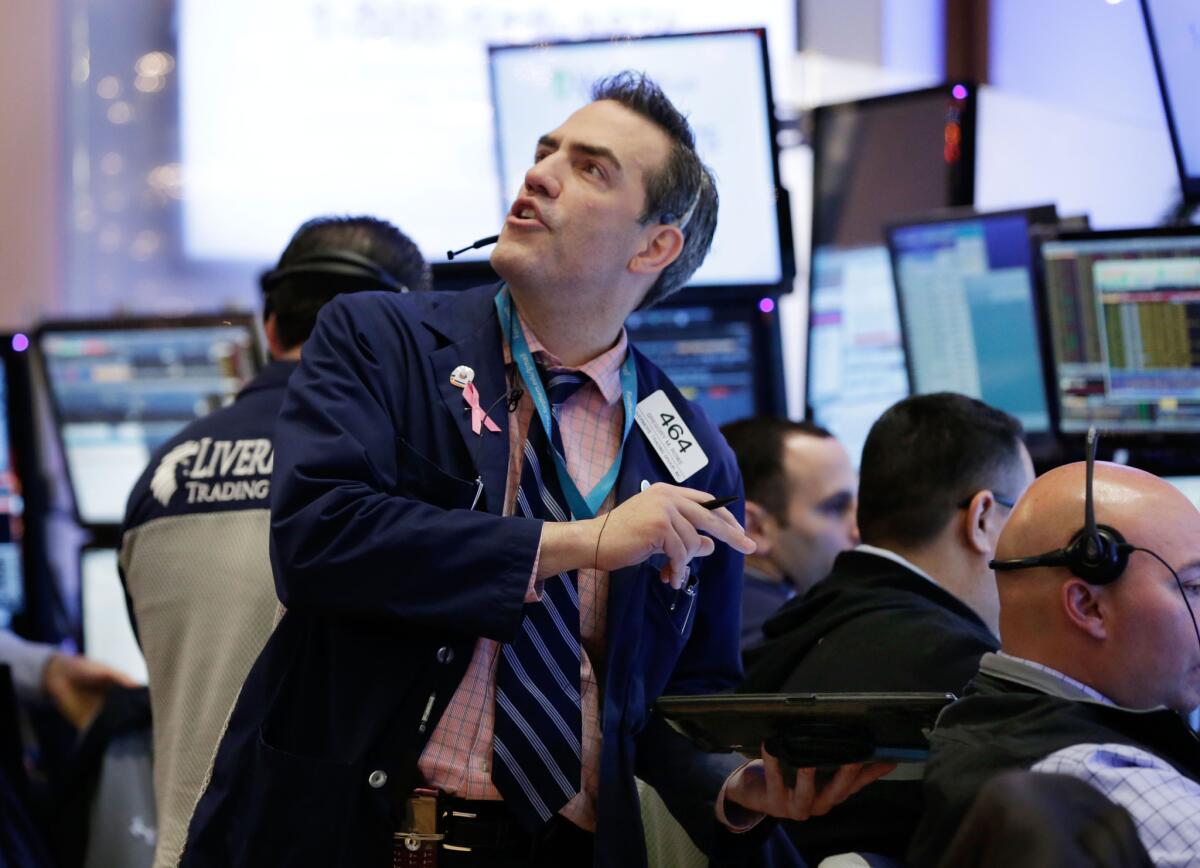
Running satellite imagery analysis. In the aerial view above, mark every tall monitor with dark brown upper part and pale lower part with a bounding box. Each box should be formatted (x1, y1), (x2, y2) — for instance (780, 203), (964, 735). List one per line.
(805, 83), (976, 463)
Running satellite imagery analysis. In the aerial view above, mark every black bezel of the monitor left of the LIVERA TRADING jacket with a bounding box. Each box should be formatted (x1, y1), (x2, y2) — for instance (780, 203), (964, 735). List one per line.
(30, 312), (263, 530)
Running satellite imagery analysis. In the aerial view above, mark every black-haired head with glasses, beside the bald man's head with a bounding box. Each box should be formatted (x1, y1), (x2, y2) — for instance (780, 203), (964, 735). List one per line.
(858, 393), (1033, 631)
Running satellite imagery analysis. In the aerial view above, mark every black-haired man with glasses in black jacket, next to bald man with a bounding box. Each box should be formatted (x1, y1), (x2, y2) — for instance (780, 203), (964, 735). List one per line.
(740, 393), (1033, 860)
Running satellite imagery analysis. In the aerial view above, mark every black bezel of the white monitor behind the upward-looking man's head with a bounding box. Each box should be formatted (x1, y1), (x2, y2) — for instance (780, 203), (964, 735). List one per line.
(487, 28), (796, 301)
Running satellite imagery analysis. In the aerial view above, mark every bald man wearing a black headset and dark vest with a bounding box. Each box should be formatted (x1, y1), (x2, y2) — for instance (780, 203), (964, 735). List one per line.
(910, 441), (1200, 866)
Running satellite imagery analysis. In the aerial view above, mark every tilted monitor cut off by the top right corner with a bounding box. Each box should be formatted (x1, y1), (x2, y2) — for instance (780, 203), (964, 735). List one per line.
(1141, 0), (1200, 202)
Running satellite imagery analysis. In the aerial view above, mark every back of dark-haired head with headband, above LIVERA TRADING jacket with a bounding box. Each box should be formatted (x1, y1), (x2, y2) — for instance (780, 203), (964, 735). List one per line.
(263, 217), (431, 355)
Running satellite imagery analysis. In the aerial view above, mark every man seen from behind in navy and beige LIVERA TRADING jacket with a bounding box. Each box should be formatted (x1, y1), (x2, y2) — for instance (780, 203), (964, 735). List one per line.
(120, 217), (430, 868)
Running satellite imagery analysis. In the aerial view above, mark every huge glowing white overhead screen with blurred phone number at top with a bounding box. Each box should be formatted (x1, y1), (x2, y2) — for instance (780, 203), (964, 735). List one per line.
(176, 0), (796, 262)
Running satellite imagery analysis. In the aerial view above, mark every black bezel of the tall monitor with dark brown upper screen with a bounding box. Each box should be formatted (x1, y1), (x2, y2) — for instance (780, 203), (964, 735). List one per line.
(804, 80), (979, 424)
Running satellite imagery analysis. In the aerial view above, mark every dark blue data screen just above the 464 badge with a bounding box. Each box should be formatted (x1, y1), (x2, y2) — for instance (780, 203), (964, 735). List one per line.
(625, 307), (758, 425)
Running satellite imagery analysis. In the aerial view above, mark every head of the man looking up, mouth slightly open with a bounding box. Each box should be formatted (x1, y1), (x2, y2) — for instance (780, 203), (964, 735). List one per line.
(492, 73), (716, 333)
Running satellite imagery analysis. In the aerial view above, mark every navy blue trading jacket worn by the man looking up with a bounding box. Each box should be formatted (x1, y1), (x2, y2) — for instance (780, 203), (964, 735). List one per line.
(182, 287), (769, 868)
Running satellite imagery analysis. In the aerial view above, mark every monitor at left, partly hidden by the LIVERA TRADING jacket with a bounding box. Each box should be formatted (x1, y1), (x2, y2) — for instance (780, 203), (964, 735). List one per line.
(36, 315), (259, 526)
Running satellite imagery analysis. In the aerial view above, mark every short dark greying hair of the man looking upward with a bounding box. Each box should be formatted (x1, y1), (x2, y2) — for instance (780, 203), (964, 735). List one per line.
(592, 71), (720, 309)
